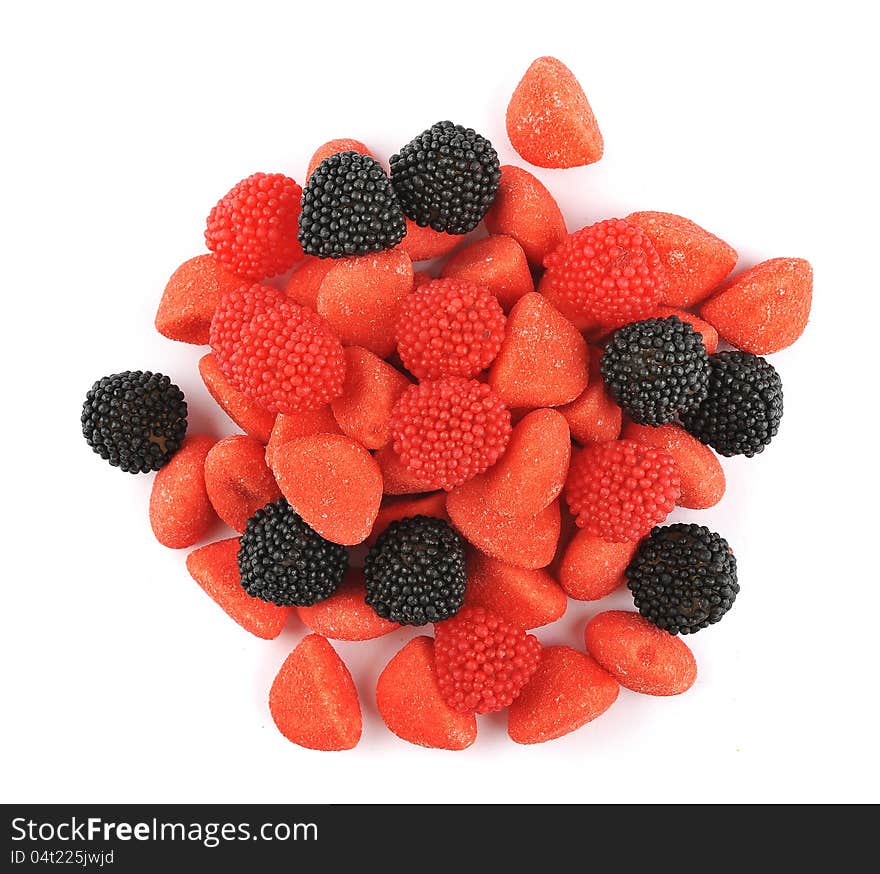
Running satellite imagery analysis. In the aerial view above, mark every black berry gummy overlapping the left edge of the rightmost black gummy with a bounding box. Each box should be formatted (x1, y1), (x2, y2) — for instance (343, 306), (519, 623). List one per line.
(601, 316), (709, 427)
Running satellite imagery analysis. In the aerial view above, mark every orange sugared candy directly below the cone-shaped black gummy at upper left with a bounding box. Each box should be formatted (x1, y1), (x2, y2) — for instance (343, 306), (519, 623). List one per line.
(318, 249), (413, 358)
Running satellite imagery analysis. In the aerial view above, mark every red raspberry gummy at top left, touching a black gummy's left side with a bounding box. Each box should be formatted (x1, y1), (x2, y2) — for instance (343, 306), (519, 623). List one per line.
(205, 173), (303, 279)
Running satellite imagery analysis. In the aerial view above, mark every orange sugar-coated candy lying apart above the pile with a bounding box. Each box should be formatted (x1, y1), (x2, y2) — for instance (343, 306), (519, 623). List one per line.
(506, 57), (604, 168)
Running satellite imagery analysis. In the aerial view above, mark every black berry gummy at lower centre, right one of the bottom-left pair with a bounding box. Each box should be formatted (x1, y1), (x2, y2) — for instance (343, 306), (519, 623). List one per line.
(364, 516), (467, 625)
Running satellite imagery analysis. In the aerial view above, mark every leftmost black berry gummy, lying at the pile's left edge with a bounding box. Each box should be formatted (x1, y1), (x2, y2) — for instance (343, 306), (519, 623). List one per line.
(82, 370), (186, 473)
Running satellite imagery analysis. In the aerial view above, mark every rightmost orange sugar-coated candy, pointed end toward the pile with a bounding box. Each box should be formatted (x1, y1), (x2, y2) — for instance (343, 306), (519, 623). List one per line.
(700, 258), (813, 355)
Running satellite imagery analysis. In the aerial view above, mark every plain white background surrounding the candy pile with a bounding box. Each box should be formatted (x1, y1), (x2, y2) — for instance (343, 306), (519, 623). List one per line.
(0, 0), (880, 802)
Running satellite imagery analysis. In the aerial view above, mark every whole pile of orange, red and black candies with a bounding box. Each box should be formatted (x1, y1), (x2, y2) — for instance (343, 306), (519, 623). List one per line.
(82, 58), (812, 750)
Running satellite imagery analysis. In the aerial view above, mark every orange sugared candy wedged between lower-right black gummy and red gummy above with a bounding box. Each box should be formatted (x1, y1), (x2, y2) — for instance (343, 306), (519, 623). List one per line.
(557, 528), (639, 601)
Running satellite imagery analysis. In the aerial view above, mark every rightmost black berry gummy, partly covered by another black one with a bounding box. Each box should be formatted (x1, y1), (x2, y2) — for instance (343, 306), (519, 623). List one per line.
(681, 352), (782, 458)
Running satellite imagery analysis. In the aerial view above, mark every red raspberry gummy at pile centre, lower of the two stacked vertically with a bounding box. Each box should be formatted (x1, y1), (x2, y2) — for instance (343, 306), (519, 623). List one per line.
(391, 376), (511, 491)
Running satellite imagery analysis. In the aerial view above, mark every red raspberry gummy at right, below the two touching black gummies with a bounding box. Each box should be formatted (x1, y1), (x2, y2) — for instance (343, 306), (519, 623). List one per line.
(565, 440), (681, 543)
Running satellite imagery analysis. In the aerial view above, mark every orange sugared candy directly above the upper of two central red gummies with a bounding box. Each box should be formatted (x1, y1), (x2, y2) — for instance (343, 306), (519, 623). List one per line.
(440, 234), (535, 312)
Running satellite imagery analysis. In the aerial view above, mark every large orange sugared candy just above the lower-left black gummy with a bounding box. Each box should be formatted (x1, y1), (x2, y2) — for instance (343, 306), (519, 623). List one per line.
(272, 434), (382, 546)
